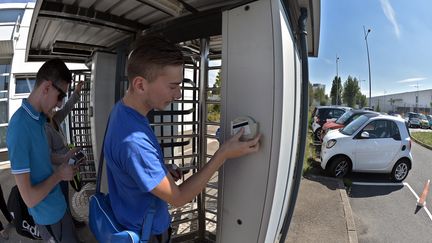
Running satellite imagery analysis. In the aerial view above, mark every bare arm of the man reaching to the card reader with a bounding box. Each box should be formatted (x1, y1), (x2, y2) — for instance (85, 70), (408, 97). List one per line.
(151, 132), (260, 207)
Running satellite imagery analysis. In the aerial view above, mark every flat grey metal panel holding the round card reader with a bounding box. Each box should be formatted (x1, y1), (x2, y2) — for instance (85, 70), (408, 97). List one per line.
(217, 0), (281, 243)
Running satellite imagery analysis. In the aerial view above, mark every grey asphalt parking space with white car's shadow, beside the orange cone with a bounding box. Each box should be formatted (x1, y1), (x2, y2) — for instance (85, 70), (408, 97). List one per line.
(349, 182), (432, 242)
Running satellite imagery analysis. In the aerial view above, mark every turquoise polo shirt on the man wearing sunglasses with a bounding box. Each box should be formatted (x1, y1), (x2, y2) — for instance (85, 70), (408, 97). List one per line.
(6, 99), (66, 225)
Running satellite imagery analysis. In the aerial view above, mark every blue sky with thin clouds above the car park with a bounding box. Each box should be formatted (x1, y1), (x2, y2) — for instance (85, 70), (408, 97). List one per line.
(309, 0), (432, 96)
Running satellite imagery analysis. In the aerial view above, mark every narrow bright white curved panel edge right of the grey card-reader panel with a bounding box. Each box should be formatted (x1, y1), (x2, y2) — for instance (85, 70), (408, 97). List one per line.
(259, 0), (301, 242)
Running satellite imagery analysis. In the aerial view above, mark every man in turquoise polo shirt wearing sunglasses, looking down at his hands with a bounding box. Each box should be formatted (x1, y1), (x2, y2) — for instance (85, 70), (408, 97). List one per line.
(6, 59), (78, 242)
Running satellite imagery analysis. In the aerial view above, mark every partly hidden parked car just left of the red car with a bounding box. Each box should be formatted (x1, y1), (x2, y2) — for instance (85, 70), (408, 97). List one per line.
(312, 106), (351, 140)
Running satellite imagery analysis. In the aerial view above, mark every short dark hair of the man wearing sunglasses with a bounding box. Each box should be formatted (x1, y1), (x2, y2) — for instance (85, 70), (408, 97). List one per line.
(35, 58), (72, 87)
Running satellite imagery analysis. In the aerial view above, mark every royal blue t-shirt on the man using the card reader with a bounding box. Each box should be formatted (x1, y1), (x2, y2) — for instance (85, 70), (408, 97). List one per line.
(104, 101), (171, 234)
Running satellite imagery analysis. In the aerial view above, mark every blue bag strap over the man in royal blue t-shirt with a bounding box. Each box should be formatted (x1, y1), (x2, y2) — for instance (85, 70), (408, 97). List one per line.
(96, 112), (156, 242)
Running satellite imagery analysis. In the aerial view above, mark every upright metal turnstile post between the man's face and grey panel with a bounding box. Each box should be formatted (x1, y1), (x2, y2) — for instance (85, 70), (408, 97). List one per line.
(198, 38), (209, 242)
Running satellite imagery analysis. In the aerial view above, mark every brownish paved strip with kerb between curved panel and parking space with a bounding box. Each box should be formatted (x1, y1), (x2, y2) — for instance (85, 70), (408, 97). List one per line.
(286, 175), (358, 243)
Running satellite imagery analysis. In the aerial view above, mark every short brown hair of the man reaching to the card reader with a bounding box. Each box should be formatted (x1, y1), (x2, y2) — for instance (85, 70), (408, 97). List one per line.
(127, 35), (184, 82)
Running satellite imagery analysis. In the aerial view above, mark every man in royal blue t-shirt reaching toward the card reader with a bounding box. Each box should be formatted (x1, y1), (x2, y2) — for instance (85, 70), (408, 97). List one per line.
(104, 36), (259, 242)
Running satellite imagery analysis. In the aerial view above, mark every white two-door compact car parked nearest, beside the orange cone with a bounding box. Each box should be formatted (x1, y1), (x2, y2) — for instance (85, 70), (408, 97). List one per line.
(321, 113), (412, 182)
